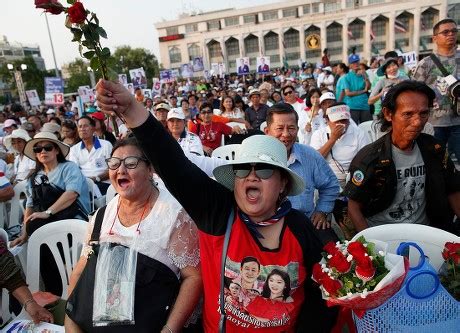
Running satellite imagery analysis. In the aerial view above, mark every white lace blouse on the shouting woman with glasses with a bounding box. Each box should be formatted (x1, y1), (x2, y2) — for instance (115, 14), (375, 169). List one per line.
(82, 186), (200, 277)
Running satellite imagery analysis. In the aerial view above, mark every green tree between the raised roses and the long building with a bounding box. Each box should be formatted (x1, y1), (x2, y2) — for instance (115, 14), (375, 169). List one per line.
(112, 45), (160, 86)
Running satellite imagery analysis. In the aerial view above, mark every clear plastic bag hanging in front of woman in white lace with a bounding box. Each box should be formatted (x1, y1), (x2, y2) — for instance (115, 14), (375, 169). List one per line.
(93, 243), (137, 327)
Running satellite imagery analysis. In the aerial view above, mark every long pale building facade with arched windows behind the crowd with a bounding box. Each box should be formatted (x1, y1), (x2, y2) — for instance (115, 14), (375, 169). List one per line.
(155, 0), (460, 74)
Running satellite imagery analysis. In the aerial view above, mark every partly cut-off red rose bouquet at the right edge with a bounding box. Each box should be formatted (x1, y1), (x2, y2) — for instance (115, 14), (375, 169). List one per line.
(439, 242), (460, 301)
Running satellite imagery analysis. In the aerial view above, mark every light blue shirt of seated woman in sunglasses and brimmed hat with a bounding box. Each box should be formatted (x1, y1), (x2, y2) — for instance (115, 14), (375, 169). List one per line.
(26, 161), (90, 213)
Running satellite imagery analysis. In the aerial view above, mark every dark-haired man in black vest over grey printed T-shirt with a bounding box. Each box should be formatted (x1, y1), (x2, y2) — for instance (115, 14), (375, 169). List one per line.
(344, 80), (460, 233)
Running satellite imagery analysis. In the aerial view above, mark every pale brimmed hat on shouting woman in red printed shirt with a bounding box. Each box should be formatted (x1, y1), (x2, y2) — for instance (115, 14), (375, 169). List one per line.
(213, 135), (305, 195)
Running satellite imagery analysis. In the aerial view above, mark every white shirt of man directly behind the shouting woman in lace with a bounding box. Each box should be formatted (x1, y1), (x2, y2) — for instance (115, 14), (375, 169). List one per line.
(69, 137), (112, 182)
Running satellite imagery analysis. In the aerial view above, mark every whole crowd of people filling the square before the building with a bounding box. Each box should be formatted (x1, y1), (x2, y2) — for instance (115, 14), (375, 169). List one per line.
(0, 19), (460, 333)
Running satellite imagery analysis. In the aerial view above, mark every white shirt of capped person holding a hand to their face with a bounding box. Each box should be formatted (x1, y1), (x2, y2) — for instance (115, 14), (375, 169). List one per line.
(310, 121), (370, 188)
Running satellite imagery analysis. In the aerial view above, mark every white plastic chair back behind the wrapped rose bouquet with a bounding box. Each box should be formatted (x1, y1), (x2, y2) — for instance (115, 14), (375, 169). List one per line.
(353, 223), (460, 270)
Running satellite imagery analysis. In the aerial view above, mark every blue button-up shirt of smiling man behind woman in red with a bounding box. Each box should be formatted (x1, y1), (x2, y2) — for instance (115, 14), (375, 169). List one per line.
(288, 143), (340, 218)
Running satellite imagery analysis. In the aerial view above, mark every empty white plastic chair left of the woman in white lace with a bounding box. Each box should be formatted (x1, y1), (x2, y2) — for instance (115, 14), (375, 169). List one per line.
(26, 219), (88, 299)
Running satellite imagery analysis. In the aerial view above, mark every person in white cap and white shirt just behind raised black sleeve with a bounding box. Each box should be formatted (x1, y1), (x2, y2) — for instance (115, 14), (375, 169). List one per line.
(164, 108), (204, 155)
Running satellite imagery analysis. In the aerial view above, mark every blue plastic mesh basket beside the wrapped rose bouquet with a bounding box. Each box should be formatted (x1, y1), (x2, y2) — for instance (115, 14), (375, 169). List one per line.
(353, 242), (460, 333)
